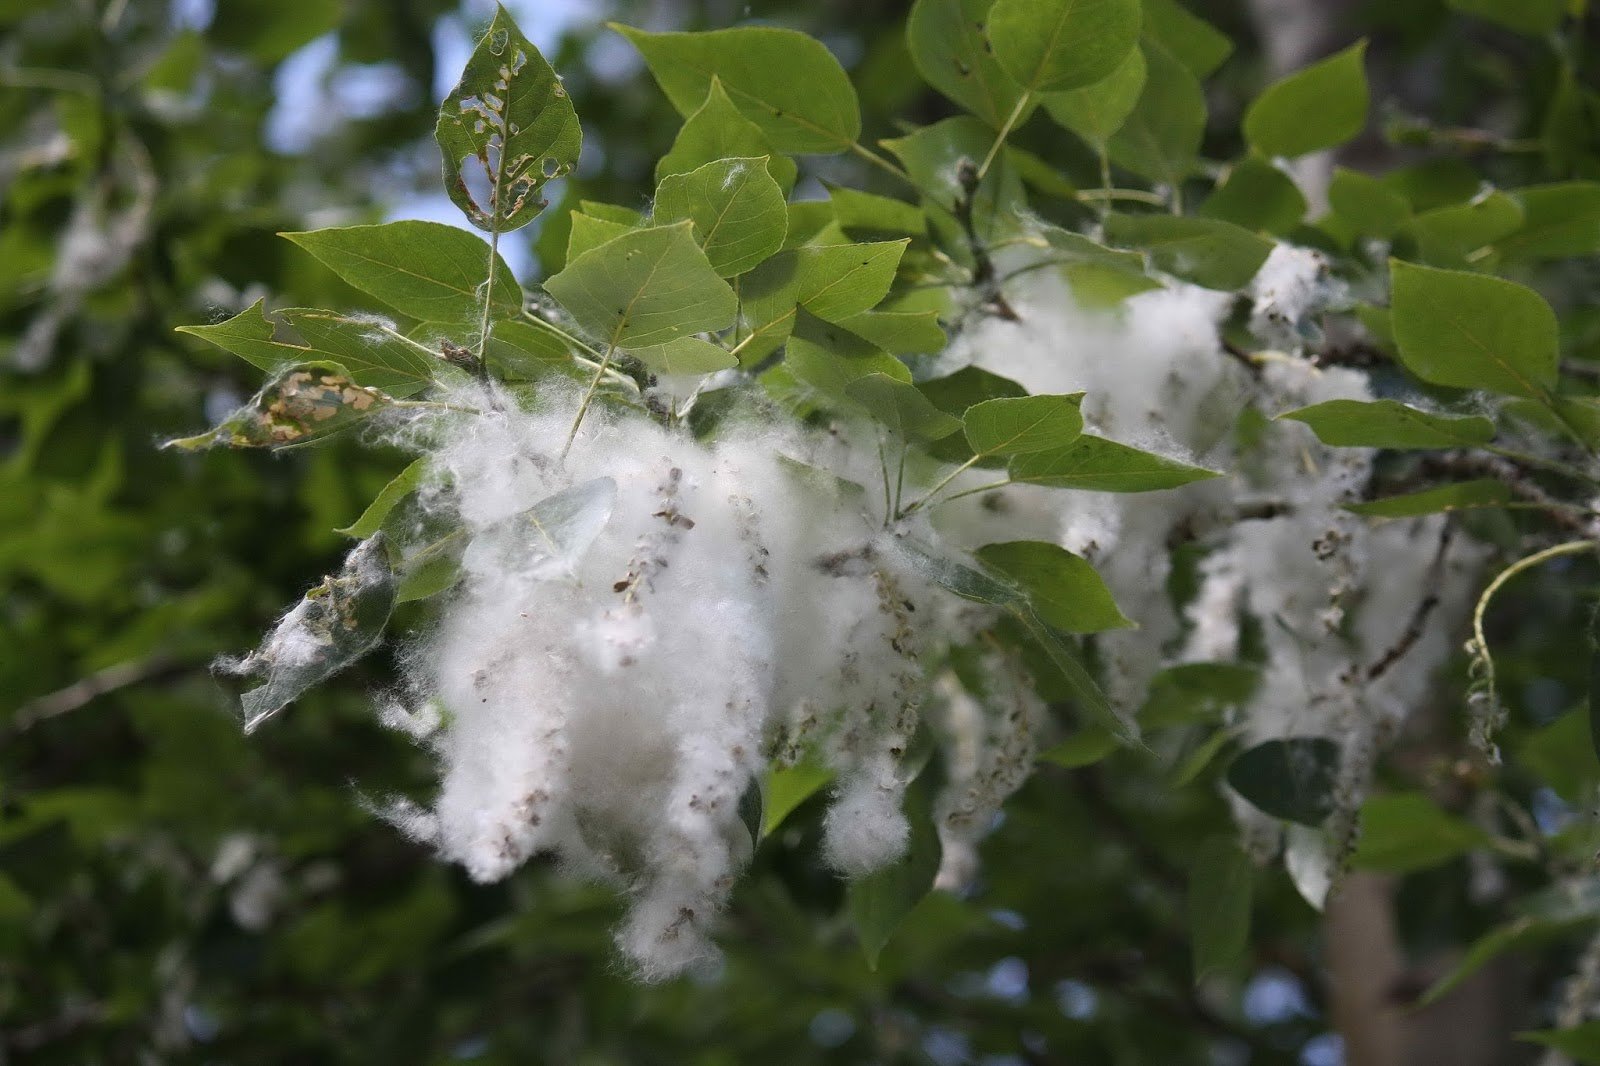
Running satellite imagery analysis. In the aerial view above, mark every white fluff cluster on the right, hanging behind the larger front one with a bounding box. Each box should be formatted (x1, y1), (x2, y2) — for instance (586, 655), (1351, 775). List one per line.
(944, 245), (1483, 879)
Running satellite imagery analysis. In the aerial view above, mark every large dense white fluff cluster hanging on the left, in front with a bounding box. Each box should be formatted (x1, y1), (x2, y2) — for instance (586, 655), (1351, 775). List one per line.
(363, 379), (998, 978)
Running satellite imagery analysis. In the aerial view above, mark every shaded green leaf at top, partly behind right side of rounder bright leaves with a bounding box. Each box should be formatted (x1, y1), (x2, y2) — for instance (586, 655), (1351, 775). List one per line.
(1106, 40), (1206, 186)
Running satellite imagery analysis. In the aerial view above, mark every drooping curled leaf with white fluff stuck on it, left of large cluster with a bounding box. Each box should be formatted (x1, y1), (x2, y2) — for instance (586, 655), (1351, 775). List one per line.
(226, 535), (395, 733)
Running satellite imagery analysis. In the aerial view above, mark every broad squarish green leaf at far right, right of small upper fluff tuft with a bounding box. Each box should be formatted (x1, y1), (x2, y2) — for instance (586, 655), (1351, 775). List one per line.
(1390, 259), (1557, 399)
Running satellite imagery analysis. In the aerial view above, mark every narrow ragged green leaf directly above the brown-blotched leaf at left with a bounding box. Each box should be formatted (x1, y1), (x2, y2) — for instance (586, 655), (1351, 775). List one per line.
(178, 299), (438, 397)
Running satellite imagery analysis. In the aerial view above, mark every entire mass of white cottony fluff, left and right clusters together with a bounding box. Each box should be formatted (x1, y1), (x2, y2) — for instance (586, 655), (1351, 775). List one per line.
(334, 235), (1475, 978)
